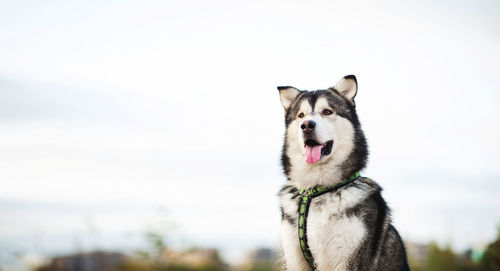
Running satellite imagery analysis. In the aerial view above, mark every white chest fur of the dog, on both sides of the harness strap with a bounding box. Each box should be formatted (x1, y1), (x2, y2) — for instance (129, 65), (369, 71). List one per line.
(281, 187), (365, 270)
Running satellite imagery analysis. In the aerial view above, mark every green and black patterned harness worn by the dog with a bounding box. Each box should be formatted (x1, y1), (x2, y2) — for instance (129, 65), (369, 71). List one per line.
(298, 172), (360, 270)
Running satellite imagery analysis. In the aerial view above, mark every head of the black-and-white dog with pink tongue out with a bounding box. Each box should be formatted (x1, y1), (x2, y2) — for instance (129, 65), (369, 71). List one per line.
(278, 75), (367, 187)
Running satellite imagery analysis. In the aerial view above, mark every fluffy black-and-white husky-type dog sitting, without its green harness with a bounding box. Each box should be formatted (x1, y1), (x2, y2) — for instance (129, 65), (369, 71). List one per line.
(278, 75), (409, 271)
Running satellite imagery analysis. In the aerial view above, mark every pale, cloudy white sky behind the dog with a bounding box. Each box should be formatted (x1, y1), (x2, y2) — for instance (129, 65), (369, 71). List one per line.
(0, 0), (500, 268)
